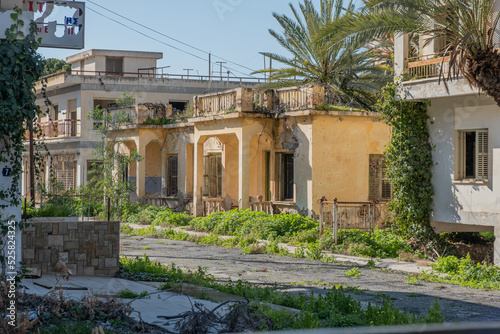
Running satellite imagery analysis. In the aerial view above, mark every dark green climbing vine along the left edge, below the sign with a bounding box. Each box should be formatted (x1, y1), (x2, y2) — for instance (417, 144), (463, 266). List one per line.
(0, 9), (43, 210)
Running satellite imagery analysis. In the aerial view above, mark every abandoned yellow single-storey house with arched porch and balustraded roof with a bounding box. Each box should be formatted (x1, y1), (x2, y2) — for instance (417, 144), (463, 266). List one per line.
(111, 85), (391, 216)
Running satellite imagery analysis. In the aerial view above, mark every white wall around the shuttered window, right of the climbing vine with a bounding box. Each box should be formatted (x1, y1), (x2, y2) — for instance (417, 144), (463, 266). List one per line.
(428, 95), (500, 226)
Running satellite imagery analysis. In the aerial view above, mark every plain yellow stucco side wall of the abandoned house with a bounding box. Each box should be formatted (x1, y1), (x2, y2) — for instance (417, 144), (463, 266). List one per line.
(312, 115), (391, 214)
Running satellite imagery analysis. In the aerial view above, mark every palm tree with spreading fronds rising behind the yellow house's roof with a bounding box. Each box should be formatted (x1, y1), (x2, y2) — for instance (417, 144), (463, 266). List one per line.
(256, 0), (391, 109)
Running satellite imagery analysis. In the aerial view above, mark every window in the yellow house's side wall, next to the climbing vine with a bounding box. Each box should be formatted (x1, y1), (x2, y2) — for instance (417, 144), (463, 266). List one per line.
(368, 155), (392, 201)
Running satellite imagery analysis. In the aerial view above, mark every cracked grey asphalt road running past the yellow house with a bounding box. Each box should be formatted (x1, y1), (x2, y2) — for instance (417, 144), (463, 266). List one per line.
(121, 234), (500, 322)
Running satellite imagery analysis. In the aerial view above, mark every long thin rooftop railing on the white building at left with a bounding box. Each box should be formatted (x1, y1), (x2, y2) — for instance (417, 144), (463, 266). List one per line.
(40, 69), (267, 84)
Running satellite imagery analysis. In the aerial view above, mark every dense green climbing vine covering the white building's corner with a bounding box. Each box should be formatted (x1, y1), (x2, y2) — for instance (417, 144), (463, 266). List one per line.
(376, 83), (438, 247)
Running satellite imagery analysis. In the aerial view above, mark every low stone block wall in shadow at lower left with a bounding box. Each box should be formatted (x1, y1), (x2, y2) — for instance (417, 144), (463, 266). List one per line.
(22, 218), (120, 276)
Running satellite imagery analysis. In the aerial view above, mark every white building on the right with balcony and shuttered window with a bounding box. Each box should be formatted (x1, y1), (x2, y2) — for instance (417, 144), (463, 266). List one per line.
(395, 32), (500, 264)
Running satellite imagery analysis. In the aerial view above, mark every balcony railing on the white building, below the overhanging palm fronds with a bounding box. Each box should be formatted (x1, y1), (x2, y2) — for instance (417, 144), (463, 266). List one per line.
(407, 54), (450, 79)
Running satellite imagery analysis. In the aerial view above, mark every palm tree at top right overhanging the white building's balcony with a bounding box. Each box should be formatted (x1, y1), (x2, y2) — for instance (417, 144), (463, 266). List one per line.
(315, 0), (500, 106)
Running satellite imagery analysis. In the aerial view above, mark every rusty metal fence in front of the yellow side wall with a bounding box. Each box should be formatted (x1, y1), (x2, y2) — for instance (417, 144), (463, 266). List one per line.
(319, 199), (385, 244)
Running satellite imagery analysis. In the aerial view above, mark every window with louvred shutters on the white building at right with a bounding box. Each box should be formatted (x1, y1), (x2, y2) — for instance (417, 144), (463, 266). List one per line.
(457, 130), (488, 180)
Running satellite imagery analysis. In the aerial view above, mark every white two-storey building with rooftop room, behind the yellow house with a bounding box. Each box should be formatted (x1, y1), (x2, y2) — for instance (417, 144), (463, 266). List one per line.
(22, 50), (258, 200)
